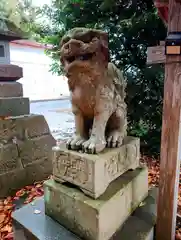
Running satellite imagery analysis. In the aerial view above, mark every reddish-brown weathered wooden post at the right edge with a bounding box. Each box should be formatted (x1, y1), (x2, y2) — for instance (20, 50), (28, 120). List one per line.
(156, 0), (181, 240)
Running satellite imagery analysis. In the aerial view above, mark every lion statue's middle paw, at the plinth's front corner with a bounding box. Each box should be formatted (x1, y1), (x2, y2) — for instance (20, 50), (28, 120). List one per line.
(82, 138), (106, 154)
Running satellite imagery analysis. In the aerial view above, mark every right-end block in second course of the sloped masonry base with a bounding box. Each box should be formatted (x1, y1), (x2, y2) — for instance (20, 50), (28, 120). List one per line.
(17, 135), (56, 167)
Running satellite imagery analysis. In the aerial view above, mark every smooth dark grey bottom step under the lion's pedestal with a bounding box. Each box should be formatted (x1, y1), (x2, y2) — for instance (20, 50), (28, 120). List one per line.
(12, 189), (157, 240)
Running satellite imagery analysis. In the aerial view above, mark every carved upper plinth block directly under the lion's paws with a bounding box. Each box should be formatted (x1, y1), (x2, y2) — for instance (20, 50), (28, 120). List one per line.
(53, 137), (140, 199)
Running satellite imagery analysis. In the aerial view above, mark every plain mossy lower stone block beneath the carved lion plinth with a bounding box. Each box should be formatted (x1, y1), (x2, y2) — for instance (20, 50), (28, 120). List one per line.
(44, 168), (148, 240)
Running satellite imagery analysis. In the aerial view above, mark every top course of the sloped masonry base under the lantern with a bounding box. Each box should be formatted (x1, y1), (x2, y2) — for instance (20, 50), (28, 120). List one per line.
(0, 114), (50, 143)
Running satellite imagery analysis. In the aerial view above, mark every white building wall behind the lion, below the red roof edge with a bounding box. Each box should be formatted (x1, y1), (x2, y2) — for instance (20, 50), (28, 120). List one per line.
(10, 44), (69, 100)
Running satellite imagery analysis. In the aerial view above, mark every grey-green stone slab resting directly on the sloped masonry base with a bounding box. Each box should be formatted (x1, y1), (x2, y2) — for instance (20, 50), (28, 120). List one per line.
(0, 97), (30, 116)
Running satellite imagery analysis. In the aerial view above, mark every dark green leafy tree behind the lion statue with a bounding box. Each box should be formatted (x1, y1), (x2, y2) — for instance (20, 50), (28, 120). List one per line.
(42, 0), (166, 154)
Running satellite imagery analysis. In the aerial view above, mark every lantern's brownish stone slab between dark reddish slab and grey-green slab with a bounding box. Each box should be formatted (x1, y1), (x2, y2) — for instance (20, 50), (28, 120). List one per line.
(0, 81), (23, 97)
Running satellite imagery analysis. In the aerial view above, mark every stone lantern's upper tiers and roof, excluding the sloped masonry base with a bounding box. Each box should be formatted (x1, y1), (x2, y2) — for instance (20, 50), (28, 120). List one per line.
(0, 18), (29, 117)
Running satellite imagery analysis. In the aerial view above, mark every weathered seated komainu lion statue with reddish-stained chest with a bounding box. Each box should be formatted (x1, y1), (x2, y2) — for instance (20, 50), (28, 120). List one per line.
(60, 28), (127, 154)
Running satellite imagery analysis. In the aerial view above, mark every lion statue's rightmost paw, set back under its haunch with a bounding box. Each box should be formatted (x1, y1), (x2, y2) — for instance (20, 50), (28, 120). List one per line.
(107, 131), (123, 148)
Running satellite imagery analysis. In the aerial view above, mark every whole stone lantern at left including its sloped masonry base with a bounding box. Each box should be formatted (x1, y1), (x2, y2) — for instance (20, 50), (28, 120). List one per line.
(0, 18), (56, 198)
